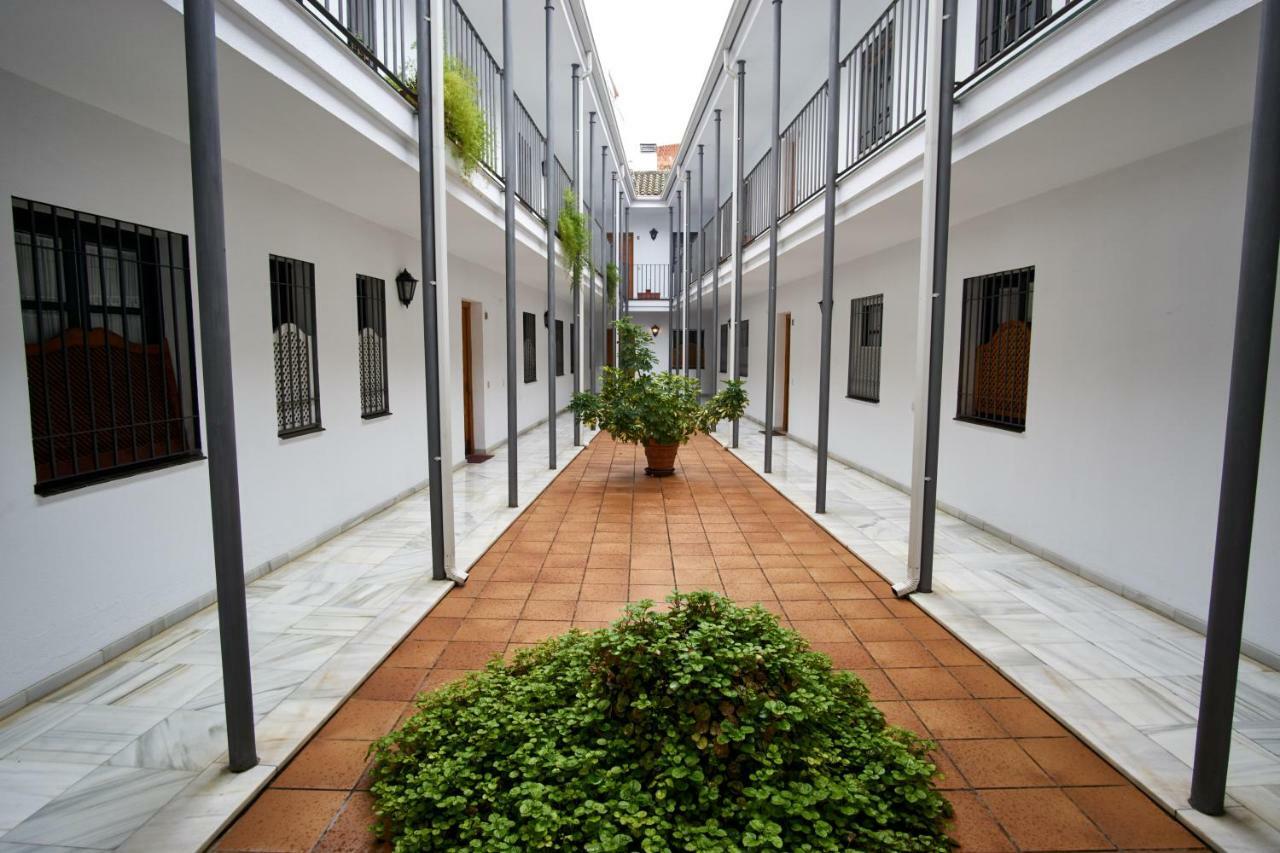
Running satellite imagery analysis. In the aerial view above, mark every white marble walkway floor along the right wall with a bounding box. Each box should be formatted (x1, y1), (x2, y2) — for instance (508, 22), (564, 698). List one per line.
(717, 421), (1280, 850)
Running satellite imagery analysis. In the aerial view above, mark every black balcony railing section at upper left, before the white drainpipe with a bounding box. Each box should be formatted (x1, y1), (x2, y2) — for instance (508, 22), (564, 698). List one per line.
(298, 0), (417, 104)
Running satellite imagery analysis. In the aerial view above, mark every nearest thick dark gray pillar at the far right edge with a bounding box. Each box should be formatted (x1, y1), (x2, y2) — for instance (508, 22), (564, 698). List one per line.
(1190, 0), (1280, 815)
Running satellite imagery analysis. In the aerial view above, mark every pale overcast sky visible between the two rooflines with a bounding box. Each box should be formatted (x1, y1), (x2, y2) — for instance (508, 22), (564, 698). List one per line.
(585, 0), (731, 158)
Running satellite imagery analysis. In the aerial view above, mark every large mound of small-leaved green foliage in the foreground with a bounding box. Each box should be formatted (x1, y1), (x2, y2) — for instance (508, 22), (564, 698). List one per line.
(371, 592), (951, 853)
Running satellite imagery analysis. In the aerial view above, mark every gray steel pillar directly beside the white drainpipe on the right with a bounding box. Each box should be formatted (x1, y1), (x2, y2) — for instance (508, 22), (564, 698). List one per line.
(915, 0), (956, 593)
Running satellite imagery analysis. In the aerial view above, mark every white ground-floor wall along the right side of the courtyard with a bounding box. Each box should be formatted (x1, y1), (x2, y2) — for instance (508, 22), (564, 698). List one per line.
(744, 129), (1280, 653)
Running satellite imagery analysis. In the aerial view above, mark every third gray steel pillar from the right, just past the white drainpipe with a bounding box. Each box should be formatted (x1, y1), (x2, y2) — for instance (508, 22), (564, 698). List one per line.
(814, 0), (841, 512)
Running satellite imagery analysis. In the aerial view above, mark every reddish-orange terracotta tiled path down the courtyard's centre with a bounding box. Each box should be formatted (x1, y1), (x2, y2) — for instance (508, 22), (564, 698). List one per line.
(216, 435), (1203, 852)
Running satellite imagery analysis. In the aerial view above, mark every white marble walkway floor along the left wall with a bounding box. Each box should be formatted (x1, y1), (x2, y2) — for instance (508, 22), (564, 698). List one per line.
(0, 416), (591, 853)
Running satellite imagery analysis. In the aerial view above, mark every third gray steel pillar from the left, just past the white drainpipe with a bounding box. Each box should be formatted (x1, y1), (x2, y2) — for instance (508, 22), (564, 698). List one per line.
(502, 0), (520, 506)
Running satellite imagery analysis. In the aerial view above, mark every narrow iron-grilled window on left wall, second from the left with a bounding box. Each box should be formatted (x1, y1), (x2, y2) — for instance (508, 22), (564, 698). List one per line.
(270, 255), (320, 438)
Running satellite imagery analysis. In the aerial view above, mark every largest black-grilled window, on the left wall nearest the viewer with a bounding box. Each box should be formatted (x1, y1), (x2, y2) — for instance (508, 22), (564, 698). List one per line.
(13, 197), (200, 494)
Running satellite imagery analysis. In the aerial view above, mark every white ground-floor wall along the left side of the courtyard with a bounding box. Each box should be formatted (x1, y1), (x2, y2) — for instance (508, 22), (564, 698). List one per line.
(0, 72), (572, 701)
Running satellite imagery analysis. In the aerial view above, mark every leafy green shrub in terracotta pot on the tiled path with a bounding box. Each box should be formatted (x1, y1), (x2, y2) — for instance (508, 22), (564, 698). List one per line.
(570, 318), (746, 476)
